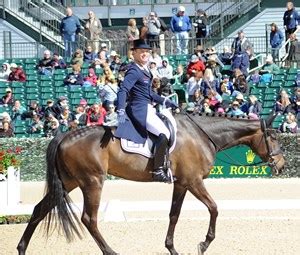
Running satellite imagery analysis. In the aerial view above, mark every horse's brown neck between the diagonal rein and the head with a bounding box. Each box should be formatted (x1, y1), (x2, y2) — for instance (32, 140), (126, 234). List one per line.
(199, 118), (260, 151)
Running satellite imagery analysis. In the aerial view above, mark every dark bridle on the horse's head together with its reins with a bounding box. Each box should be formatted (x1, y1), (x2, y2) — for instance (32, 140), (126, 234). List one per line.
(182, 111), (282, 174)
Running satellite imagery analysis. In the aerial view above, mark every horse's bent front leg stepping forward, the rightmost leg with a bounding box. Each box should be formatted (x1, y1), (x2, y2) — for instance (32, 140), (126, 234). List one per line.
(188, 177), (218, 254)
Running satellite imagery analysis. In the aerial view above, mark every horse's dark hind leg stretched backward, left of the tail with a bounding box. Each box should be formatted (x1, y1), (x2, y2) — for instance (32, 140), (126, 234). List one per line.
(17, 194), (56, 255)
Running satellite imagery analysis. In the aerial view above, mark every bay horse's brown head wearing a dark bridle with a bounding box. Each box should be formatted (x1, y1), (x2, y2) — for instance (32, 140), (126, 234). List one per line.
(250, 115), (285, 175)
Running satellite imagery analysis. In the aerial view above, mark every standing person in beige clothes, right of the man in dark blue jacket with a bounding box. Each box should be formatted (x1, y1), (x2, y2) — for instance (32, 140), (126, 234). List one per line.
(84, 11), (102, 52)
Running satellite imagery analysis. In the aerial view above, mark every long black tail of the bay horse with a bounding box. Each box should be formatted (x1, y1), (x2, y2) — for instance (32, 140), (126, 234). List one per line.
(46, 133), (81, 241)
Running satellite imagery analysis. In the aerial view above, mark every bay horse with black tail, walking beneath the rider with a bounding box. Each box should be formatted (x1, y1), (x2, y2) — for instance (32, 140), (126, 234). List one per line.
(17, 113), (284, 255)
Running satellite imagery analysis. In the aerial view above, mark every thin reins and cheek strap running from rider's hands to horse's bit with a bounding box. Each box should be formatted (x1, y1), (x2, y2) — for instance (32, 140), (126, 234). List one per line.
(182, 110), (276, 167)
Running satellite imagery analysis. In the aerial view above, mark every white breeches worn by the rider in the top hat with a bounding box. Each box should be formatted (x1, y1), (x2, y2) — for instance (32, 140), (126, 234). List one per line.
(146, 104), (170, 140)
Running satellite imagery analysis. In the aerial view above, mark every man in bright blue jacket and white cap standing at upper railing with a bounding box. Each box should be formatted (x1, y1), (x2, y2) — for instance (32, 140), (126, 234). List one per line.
(170, 6), (192, 55)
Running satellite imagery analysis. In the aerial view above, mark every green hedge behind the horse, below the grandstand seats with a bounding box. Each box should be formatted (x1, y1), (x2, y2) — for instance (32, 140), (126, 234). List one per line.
(0, 134), (300, 181)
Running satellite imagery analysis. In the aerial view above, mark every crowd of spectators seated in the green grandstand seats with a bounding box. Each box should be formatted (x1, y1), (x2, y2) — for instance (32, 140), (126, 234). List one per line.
(0, 37), (300, 137)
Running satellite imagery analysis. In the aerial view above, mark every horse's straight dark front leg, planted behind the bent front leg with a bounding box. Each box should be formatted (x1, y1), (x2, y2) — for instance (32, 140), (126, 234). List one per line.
(165, 183), (187, 255)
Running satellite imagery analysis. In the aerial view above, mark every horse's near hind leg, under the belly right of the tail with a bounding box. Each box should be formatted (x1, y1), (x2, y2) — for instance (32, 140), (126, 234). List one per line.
(81, 176), (117, 255)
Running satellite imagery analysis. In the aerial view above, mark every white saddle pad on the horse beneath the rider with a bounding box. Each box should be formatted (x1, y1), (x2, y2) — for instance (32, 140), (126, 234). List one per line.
(121, 109), (177, 158)
